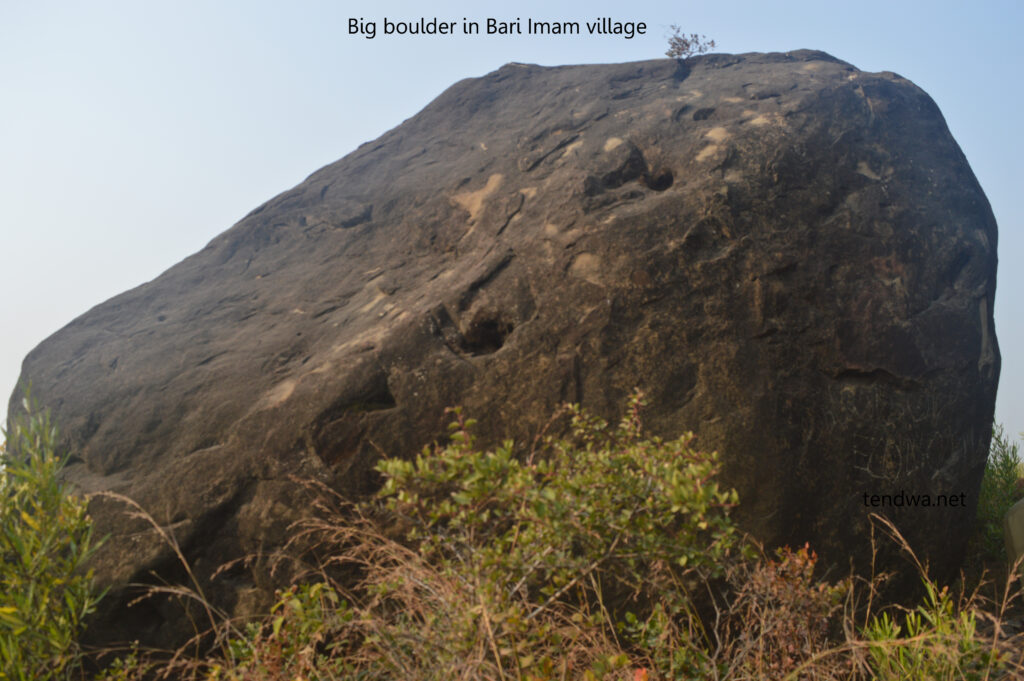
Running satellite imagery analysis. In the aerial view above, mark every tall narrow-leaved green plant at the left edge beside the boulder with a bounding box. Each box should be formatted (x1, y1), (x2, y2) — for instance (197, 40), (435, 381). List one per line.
(0, 398), (100, 681)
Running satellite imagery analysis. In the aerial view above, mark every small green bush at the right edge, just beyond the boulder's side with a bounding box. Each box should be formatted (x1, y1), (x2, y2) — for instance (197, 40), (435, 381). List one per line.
(968, 426), (1024, 563)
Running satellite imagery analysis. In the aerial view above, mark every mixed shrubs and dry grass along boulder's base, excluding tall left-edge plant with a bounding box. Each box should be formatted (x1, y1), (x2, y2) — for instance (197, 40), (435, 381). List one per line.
(88, 395), (1024, 681)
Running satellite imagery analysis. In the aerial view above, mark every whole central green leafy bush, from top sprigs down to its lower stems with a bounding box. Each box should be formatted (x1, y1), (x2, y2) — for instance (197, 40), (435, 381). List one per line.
(370, 395), (739, 678)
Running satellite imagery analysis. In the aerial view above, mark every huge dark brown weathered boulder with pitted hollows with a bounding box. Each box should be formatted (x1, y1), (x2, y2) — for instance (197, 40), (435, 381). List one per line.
(11, 51), (999, 640)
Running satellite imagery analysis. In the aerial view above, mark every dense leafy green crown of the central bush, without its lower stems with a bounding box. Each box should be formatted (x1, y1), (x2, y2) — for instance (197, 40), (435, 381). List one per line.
(378, 398), (737, 607)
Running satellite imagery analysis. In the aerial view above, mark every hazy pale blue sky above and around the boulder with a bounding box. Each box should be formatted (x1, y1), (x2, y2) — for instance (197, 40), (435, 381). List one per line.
(0, 0), (1024, 440)
